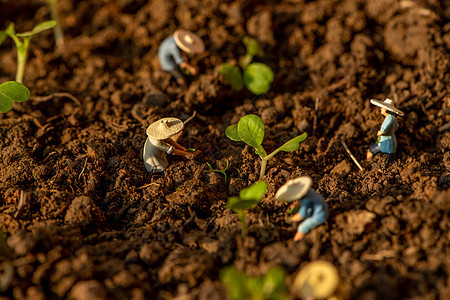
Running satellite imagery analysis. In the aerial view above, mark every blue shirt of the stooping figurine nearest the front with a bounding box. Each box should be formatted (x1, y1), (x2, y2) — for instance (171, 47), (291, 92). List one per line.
(298, 189), (328, 223)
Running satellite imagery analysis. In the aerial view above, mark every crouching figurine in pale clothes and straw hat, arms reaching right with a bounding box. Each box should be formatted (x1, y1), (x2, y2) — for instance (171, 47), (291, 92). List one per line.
(143, 118), (200, 175)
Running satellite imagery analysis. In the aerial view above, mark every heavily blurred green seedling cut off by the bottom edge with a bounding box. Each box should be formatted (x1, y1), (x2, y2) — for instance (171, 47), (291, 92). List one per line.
(220, 266), (287, 300)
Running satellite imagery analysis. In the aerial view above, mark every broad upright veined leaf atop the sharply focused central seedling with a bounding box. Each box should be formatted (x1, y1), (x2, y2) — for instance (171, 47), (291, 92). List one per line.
(237, 114), (264, 152)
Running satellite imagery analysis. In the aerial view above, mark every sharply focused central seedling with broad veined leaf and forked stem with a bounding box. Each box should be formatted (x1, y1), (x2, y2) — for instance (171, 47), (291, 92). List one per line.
(225, 114), (307, 179)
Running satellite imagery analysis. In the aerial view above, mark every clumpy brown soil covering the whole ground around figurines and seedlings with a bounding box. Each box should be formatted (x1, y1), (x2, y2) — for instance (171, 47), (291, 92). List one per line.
(0, 0), (450, 300)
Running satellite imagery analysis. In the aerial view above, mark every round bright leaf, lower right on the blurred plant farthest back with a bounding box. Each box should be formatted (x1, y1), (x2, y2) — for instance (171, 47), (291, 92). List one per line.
(244, 63), (273, 95)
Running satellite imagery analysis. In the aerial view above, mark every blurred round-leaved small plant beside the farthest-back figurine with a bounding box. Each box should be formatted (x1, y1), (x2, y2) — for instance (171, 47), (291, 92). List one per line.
(219, 37), (273, 95)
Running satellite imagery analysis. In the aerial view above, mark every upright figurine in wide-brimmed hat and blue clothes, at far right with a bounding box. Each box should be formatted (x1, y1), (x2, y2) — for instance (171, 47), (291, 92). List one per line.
(367, 98), (405, 161)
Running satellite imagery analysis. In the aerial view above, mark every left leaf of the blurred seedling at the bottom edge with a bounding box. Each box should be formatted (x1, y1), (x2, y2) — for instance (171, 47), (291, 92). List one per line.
(219, 266), (251, 300)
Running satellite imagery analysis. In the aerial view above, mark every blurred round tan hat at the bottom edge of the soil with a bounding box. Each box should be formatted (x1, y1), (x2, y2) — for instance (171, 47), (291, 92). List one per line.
(294, 260), (339, 299)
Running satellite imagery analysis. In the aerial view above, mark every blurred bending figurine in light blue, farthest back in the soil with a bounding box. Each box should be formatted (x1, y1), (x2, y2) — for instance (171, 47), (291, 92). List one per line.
(158, 29), (205, 87)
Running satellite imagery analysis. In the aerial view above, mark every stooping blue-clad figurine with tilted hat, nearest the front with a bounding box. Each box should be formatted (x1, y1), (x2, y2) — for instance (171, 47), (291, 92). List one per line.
(275, 176), (328, 241)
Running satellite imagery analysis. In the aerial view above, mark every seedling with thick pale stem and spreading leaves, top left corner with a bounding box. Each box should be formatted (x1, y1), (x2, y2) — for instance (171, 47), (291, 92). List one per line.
(0, 21), (57, 83)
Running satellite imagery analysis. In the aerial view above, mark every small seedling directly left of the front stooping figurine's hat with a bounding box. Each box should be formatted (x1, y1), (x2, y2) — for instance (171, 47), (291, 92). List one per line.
(227, 181), (267, 237)
